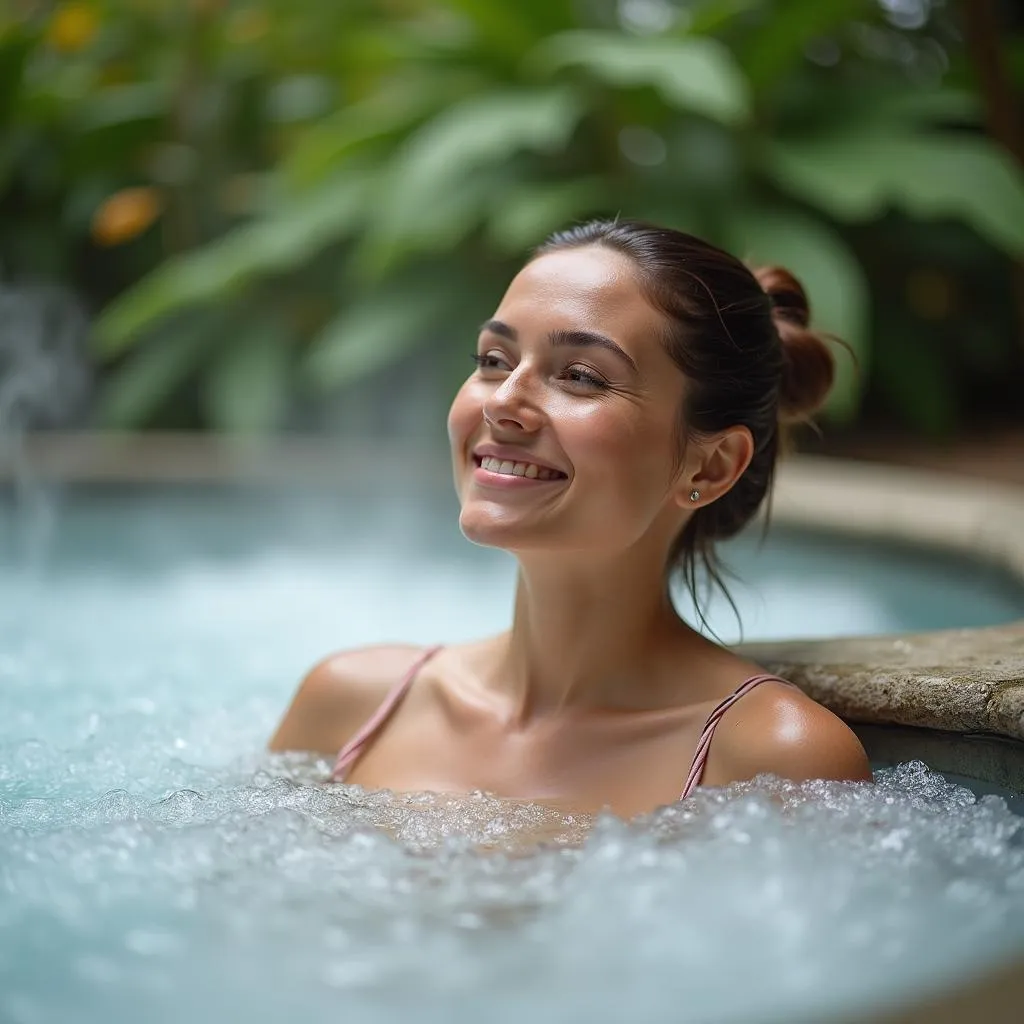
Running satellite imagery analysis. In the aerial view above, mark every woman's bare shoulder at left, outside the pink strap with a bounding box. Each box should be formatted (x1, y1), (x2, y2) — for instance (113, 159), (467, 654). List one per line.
(268, 644), (425, 754)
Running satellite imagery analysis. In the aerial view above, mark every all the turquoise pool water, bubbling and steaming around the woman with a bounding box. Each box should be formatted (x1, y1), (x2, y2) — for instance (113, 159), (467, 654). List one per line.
(0, 488), (1024, 1024)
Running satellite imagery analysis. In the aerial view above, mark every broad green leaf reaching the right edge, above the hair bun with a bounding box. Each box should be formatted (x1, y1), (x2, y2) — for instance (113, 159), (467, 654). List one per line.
(765, 128), (1024, 256)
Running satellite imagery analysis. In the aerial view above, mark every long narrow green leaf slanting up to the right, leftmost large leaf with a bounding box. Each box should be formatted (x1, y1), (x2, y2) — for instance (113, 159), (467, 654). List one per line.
(94, 176), (369, 355)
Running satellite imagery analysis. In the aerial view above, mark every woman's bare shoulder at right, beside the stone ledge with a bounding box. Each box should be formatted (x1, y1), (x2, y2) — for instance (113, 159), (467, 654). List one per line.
(702, 681), (871, 785)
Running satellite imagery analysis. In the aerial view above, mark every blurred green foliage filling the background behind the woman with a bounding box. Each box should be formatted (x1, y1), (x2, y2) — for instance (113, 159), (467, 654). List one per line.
(0, 0), (1024, 433)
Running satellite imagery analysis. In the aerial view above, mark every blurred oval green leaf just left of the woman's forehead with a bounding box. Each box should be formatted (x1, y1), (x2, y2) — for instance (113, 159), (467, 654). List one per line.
(303, 278), (452, 390)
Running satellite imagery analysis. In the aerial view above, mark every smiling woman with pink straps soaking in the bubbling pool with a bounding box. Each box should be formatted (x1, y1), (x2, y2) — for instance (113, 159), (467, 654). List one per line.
(270, 221), (870, 817)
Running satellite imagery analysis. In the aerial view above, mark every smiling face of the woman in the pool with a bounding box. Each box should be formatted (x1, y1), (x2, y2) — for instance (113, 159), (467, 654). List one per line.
(449, 246), (684, 554)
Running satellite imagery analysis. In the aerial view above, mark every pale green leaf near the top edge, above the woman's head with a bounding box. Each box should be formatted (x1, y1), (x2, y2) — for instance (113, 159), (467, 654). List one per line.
(526, 31), (751, 124)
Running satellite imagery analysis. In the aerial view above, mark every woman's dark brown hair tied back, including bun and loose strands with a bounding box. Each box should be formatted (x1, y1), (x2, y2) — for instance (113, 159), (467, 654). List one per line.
(535, 220), (835, 622)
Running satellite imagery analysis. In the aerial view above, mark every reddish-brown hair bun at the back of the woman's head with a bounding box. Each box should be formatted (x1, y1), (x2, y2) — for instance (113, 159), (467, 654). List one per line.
(754, 266), (836, 422)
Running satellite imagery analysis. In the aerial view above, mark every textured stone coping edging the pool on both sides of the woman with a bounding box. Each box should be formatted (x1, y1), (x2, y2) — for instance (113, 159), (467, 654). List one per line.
(6, 434), (1024, 739)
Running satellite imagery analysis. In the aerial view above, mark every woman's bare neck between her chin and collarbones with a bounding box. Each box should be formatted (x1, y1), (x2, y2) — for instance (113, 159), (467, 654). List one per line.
(489, 549), (684, 725)
